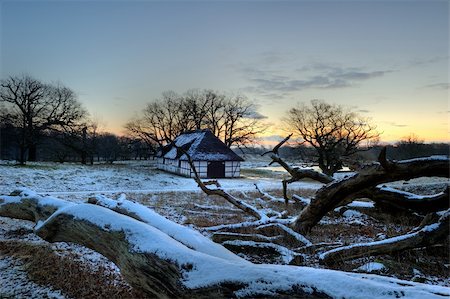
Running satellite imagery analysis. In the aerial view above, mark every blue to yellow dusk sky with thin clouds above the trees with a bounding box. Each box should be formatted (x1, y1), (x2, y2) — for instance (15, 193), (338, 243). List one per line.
(0, 0), (450, 142)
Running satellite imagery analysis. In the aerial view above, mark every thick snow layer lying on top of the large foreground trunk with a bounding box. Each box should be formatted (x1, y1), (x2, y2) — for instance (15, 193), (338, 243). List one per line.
(34, 198), (449, 298)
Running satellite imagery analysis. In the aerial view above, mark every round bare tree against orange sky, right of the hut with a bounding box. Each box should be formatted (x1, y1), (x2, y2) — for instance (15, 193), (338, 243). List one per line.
(285, 100), (380, 175)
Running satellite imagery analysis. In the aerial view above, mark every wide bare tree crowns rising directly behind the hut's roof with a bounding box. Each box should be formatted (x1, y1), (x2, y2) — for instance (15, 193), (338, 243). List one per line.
(126, 90), (263, 150)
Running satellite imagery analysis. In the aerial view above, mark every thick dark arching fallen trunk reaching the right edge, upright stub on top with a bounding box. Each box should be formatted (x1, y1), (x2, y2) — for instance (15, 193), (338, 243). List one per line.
(293, 148), (450, 233)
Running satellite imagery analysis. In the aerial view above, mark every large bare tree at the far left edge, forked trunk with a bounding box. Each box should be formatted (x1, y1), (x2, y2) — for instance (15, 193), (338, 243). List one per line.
(0, 75), (86, 164)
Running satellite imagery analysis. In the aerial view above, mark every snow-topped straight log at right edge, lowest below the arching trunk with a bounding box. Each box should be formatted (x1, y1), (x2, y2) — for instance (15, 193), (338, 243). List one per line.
(320, 210), (450, 264)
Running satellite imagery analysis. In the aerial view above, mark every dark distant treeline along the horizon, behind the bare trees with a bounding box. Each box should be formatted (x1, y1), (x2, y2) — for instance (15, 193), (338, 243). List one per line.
(0, 122), (450, 165)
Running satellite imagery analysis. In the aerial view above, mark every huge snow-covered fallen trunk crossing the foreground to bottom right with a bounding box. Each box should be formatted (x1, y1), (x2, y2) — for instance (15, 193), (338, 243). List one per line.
(0, 191), (448, 298)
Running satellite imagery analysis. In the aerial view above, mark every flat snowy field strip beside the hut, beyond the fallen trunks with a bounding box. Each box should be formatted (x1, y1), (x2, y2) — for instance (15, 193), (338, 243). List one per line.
(0, 161), (322, 201)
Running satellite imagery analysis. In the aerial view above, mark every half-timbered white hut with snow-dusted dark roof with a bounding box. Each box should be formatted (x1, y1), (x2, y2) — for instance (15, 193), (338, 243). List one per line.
(157, 130), (244, 178)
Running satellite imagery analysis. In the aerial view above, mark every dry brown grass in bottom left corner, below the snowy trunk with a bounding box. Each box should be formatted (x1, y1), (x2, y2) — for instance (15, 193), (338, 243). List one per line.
(0, 241), (145, 299)
